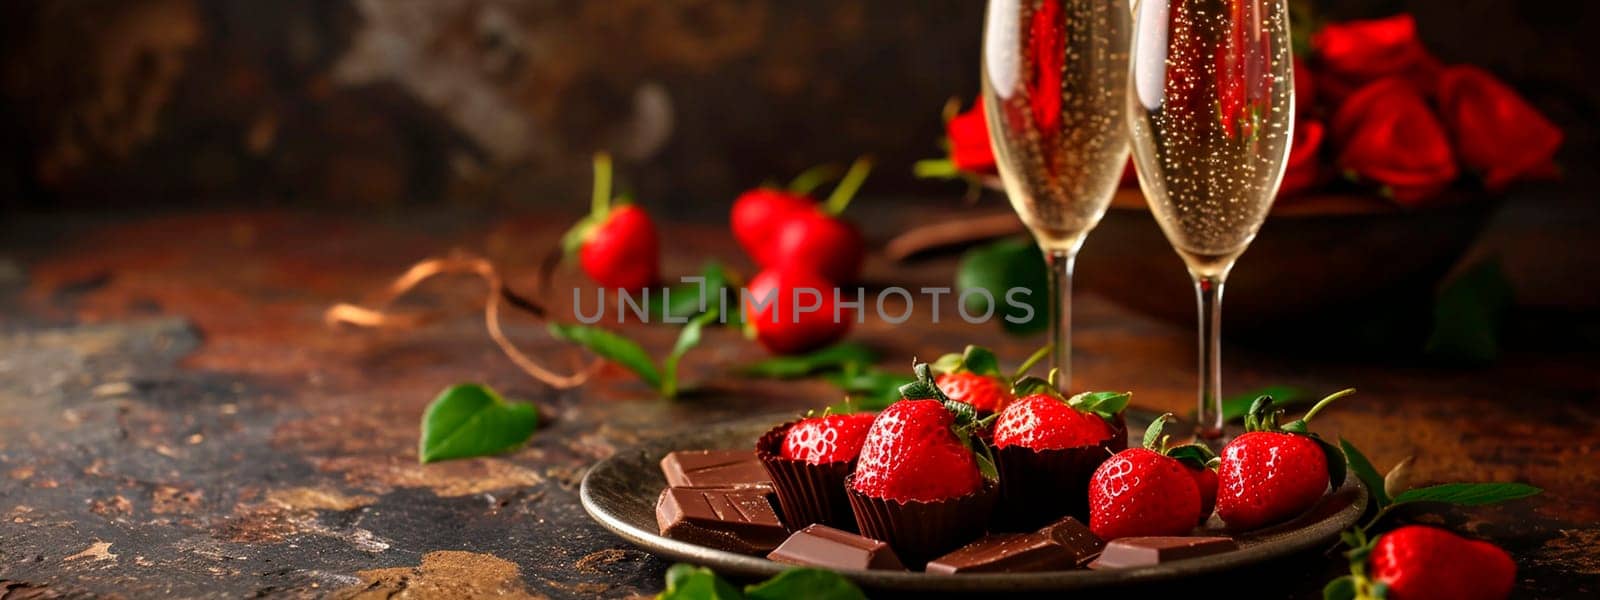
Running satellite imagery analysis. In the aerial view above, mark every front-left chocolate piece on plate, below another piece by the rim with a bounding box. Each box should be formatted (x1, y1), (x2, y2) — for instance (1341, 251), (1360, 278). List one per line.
(656, 488), (789, 554)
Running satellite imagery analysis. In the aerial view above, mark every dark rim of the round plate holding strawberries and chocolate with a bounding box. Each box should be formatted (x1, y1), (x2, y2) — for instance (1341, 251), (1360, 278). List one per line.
(578, 408), (1368, 592)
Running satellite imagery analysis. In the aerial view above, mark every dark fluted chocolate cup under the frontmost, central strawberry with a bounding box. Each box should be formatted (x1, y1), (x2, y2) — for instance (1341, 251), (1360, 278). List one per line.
(845, 474), (1000, 570)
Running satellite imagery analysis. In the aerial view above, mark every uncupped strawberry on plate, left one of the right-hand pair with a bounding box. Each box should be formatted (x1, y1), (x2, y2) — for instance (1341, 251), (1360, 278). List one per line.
(1090, 416), (1200, 539)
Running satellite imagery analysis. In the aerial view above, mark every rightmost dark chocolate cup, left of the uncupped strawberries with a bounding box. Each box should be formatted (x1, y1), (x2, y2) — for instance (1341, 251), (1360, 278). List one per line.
(992, 413), (1128, 531)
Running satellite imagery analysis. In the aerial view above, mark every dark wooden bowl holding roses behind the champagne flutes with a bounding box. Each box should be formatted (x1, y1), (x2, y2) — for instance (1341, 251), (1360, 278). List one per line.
(1075, 189), (1498, 336)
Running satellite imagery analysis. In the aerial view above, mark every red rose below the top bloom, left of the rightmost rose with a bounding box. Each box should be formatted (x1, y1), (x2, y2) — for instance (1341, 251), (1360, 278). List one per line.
(1331, 77), (1458, 206)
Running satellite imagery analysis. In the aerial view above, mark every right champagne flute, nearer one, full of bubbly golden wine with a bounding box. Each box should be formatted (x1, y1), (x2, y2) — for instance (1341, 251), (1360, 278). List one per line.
(1128, 0), (1294, 442)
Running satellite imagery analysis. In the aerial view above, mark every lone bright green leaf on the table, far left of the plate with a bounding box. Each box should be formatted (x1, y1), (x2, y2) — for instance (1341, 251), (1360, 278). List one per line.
(418, 384), (539, 464)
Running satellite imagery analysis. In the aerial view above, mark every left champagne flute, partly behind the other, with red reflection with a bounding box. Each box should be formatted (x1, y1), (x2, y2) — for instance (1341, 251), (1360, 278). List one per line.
(982, 0), (1133, 389)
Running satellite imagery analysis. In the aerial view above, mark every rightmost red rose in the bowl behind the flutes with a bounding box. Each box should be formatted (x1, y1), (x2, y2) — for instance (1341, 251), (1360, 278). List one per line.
(1438, 66), (1562, 190)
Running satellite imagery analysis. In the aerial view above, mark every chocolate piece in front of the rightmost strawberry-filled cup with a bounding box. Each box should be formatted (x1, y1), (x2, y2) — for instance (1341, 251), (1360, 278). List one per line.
(926, 517), (1104, 574)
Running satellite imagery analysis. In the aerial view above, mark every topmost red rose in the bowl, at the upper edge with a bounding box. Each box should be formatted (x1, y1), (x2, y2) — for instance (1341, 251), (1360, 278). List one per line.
(1312, 14), (1438, 101)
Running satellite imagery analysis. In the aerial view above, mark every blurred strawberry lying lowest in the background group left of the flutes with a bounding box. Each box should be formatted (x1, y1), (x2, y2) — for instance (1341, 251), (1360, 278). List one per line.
(744, 269), (854, 354)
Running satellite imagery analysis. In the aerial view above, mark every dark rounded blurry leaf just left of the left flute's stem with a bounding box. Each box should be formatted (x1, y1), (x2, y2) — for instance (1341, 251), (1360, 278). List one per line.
(955, 237), (1050, 334)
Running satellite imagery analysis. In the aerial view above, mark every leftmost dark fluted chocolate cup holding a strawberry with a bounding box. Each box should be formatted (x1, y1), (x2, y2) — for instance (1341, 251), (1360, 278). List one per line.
(755, 422), (856, 533)
